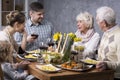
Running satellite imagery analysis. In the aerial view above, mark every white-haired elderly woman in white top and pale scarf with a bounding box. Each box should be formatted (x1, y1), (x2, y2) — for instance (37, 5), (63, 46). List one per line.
(74, 12), (100, 58)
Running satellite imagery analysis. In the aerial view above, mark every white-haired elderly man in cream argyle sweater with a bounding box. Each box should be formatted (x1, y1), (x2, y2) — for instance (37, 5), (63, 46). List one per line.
(96, 6), (120, 80)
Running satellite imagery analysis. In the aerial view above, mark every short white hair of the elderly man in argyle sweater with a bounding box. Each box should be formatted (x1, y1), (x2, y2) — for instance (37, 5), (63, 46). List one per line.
(96, 6), (116, 25)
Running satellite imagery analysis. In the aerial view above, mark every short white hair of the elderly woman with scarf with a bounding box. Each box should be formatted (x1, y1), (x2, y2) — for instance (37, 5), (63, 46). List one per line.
(76, 12), (94, 28)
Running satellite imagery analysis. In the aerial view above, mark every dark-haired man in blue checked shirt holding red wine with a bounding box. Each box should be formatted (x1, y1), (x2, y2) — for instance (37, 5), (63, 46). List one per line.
(14, 2), (54, 50)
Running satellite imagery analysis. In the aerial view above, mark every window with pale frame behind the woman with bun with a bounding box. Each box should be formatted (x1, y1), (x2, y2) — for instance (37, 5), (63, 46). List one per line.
(0, 0), (28, 26)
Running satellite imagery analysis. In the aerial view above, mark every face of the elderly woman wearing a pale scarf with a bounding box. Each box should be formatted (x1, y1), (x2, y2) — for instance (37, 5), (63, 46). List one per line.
(77, 20), (88, 34)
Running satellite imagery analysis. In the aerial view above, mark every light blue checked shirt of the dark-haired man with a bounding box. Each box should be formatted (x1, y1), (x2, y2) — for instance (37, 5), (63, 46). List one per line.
(14, 19), (54, 50)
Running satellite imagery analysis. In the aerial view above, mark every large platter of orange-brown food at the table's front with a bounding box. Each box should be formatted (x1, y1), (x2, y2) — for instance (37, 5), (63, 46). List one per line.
(56, 62), (93, 72)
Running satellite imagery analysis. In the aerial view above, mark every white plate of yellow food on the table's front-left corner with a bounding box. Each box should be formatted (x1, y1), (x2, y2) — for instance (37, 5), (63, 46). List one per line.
(36, 64), (61, 73)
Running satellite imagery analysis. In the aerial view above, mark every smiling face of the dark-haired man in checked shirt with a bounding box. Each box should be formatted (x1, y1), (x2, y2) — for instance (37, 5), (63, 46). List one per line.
(30, 10), (44, 24)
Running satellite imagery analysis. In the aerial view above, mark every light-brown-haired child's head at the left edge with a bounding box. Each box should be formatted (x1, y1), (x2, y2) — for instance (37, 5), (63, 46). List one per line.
(0, 41), (13, 63)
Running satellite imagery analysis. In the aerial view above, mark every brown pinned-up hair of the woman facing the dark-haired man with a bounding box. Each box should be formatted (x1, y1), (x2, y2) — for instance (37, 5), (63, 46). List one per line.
(6, 11), (25, 26)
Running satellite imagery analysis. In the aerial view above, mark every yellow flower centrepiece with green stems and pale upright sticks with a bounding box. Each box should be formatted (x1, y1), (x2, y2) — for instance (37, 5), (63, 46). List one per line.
(50, 32), (82, 63)
